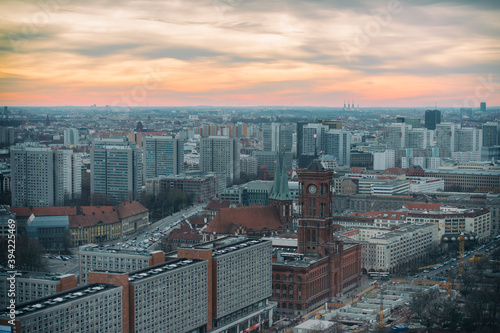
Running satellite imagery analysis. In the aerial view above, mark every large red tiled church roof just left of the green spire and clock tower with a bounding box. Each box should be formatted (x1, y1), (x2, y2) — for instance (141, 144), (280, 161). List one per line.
(204, 206), (284, 234)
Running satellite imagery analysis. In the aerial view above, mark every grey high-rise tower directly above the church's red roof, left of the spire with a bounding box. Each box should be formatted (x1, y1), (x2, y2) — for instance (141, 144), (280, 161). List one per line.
(200, 136), (240, 185)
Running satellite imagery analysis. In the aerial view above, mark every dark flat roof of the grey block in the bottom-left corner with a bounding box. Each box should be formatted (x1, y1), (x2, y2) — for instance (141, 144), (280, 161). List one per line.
(0, 283), (121, 318)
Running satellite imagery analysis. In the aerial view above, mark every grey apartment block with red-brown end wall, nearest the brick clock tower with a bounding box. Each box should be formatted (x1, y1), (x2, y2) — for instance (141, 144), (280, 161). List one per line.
(177, 237), (276, 333)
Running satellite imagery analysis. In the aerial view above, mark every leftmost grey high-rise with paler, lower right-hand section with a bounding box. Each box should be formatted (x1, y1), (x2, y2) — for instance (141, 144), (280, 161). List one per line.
(11, 145), (82, 207)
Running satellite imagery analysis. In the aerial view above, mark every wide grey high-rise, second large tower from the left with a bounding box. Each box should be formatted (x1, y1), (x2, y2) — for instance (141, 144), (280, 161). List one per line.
(90, 139), (143, 204)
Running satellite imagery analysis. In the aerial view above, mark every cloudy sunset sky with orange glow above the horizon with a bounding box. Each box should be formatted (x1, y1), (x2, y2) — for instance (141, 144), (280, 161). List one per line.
(0, 0), (500, 108)
